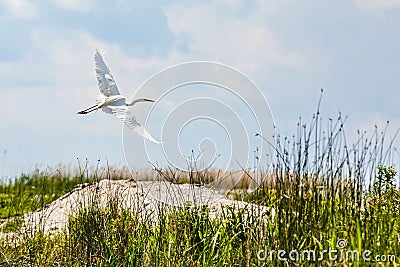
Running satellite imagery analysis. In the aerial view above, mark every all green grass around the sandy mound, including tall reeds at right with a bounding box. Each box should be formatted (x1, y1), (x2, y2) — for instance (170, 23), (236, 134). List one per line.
(0, 105), (400, 266)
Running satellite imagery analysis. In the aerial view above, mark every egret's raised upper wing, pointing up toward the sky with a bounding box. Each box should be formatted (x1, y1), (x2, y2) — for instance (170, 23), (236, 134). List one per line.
(94, 50), (120, 96)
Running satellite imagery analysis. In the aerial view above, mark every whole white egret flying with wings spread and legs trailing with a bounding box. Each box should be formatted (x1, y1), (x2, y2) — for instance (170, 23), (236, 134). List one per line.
(78, 50), (162, 144)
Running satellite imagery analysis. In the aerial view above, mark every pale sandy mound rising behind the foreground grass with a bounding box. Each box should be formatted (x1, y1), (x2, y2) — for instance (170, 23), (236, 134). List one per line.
(0, 180), (275, 241)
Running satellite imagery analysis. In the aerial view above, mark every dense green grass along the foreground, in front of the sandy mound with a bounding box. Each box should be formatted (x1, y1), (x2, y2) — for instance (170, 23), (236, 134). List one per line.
(0, 167), (400, 266)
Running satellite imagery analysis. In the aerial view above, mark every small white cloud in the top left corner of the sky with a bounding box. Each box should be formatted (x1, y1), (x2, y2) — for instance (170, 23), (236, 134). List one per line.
(0, 0), (38, 19)
